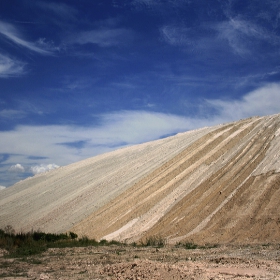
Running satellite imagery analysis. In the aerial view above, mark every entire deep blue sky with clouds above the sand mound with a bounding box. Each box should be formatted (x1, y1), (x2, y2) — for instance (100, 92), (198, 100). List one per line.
(0, 0), (280, 188)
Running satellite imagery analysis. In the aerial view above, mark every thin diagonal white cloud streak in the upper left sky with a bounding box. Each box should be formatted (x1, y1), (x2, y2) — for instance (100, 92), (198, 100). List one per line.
(0, 21), (53, 55)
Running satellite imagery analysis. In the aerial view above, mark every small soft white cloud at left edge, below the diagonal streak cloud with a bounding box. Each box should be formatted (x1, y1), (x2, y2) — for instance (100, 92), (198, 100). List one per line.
(0, 54), (25, 78)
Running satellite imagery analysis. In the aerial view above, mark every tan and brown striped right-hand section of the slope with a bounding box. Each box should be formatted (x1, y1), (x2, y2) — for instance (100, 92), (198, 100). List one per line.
(70, 112), (280, 243)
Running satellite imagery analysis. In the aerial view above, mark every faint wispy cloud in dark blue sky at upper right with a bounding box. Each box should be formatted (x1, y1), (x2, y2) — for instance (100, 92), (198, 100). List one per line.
(160, 18), (280, 56)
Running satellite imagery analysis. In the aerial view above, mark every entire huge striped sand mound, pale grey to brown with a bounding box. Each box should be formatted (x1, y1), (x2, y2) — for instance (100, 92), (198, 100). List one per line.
(0, 114), (280, 243)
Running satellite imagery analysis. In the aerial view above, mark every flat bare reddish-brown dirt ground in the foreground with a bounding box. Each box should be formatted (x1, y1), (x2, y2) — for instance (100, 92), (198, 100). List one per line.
(0, 245), (280, 280)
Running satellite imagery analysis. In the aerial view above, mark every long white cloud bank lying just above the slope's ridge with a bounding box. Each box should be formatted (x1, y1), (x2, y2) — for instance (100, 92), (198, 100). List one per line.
(0, 83), (280, 186)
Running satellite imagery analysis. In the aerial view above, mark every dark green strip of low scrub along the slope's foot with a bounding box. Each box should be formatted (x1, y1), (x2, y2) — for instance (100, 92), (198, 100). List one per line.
(0, 226), (217, 258)
